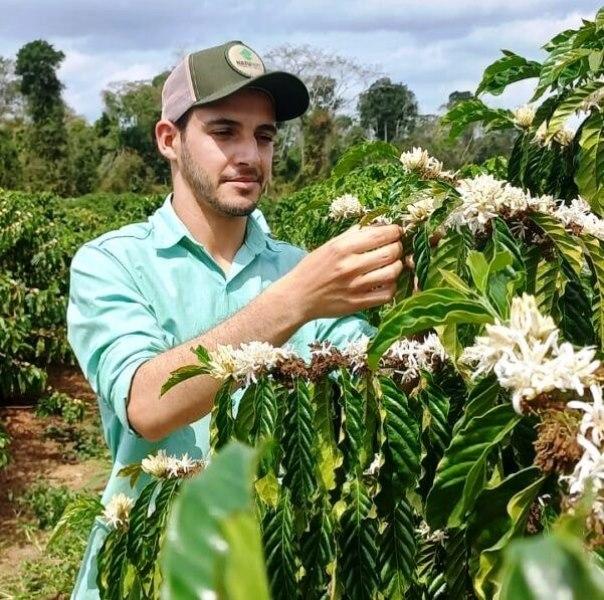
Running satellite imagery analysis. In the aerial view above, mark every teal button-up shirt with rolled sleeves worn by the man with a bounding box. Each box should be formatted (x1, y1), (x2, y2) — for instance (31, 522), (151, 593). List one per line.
(67, 195), (373, 600)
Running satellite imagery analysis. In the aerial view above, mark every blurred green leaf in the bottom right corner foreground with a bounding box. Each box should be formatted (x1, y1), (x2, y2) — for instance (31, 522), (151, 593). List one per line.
(500, 535), (604, 600)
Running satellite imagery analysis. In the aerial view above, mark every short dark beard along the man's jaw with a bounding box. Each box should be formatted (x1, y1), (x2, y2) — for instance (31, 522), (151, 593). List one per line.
(180, 140), (266, 217)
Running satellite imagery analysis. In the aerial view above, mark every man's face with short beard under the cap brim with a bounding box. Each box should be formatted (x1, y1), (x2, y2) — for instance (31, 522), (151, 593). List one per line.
(178, 89), (276, 216)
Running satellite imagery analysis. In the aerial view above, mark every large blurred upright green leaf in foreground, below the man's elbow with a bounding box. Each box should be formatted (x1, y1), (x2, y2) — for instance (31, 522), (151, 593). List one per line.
(161, 442), (268, 600)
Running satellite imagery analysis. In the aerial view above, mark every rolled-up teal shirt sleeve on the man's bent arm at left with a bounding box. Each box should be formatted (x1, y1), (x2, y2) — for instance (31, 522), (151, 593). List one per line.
(67, 245), (170, 435)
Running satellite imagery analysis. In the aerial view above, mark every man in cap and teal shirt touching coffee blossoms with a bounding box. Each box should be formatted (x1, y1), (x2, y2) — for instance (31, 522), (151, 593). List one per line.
(67, 41), (403, 599)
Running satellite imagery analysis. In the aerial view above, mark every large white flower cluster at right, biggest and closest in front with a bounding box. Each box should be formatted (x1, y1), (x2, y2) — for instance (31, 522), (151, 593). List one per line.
(461, 294), (600, 413)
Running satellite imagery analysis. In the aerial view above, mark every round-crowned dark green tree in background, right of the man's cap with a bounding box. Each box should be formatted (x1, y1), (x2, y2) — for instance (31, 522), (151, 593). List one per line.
(357, 77), (417, 141)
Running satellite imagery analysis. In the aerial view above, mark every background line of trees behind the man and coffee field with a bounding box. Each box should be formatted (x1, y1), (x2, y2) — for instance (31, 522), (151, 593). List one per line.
(0, 40), (510, 196)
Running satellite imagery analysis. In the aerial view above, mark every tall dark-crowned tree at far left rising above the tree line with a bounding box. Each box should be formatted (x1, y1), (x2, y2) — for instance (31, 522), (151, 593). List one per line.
(15, 40), (72, 195)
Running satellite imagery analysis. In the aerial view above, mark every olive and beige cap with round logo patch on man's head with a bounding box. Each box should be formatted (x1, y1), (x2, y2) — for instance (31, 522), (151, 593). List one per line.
(162, 40), (309, 122)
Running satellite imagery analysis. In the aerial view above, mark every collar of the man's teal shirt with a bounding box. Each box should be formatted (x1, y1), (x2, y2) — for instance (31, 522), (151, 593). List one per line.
(149, 193), (279, 254)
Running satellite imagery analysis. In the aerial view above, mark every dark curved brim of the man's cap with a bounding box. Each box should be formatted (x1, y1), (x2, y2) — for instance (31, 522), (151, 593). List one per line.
(191, 71), (310, 121)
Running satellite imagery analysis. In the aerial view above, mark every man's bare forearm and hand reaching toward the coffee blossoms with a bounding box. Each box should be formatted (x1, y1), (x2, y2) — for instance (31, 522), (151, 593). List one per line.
(127, 225), (403, 441)
